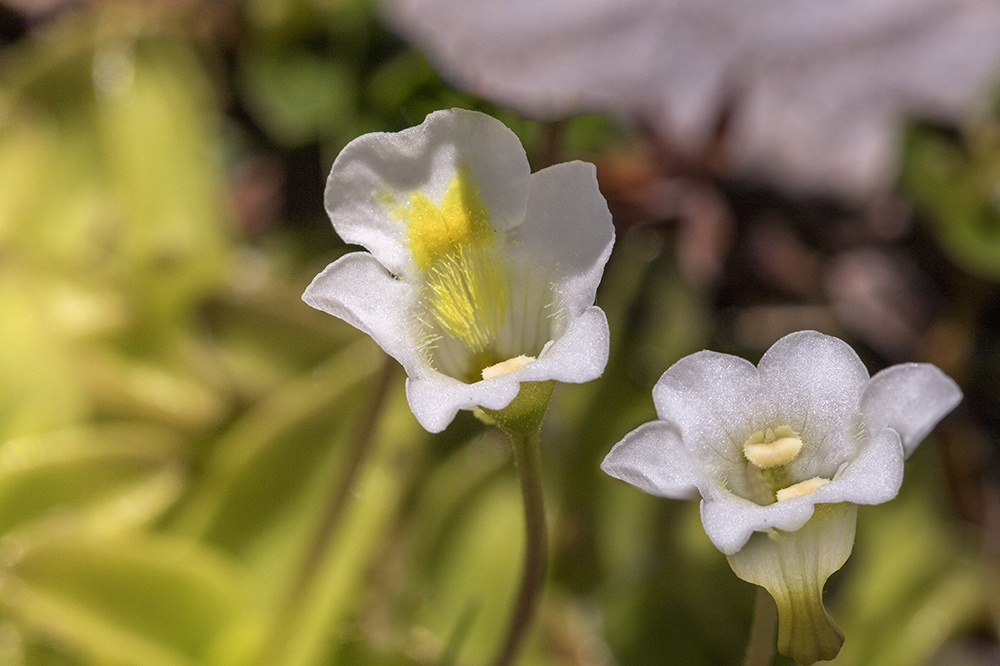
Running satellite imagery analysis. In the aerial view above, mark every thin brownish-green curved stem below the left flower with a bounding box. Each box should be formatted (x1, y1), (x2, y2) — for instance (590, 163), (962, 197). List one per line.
(493, 431), (548, 666)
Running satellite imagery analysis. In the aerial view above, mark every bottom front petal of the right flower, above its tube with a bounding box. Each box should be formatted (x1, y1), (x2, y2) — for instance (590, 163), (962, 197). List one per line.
(700, 486), (825, 555)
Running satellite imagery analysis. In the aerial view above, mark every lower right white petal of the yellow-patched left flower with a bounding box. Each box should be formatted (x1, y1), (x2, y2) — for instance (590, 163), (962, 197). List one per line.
(510, 305), (611, 384)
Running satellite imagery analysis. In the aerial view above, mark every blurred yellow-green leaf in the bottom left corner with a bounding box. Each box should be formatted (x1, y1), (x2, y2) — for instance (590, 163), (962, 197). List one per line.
(0, 531), (244, 666)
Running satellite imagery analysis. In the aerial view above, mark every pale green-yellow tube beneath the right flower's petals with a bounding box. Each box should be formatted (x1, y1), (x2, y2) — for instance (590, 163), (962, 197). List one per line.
(727, 503), (857, 664)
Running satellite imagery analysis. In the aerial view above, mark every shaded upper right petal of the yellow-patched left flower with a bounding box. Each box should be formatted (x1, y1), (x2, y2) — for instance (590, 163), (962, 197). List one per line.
(511, 162), (615, 314)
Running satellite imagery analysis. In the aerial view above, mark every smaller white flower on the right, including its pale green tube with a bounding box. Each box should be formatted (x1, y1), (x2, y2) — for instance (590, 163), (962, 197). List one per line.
(601, 331), (962, 664)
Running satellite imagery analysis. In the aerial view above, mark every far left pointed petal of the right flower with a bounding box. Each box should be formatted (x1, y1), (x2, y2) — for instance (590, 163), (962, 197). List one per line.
(601, 421), (698, 499)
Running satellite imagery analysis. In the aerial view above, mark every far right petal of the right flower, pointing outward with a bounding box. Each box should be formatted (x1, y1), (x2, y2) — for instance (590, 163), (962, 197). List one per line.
(861, 363), (962, 457)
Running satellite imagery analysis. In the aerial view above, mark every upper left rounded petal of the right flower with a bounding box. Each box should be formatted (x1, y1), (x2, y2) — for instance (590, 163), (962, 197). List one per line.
(653, 351), (760, 470)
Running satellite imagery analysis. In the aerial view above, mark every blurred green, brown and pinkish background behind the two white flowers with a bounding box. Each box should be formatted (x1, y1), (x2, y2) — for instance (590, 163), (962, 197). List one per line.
(0, 0), (1000, 666)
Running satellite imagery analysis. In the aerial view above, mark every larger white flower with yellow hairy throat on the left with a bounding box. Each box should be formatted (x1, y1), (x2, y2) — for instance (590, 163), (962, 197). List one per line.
(303, 109), (614, 432)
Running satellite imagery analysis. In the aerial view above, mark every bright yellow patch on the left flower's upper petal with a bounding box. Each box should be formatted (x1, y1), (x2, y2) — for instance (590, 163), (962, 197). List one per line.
(393, 169), (495, 270)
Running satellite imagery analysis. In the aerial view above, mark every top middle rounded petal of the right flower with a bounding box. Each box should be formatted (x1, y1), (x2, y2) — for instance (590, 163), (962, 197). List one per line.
(757, 331), (868, 478)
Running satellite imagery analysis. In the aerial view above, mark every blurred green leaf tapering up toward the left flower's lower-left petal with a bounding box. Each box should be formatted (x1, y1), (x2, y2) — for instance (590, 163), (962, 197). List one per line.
(169, 339), (381, 556)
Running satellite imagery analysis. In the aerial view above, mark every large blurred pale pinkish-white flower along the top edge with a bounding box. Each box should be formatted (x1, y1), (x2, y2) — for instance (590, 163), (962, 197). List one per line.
(385, 0), (1000, 196)
